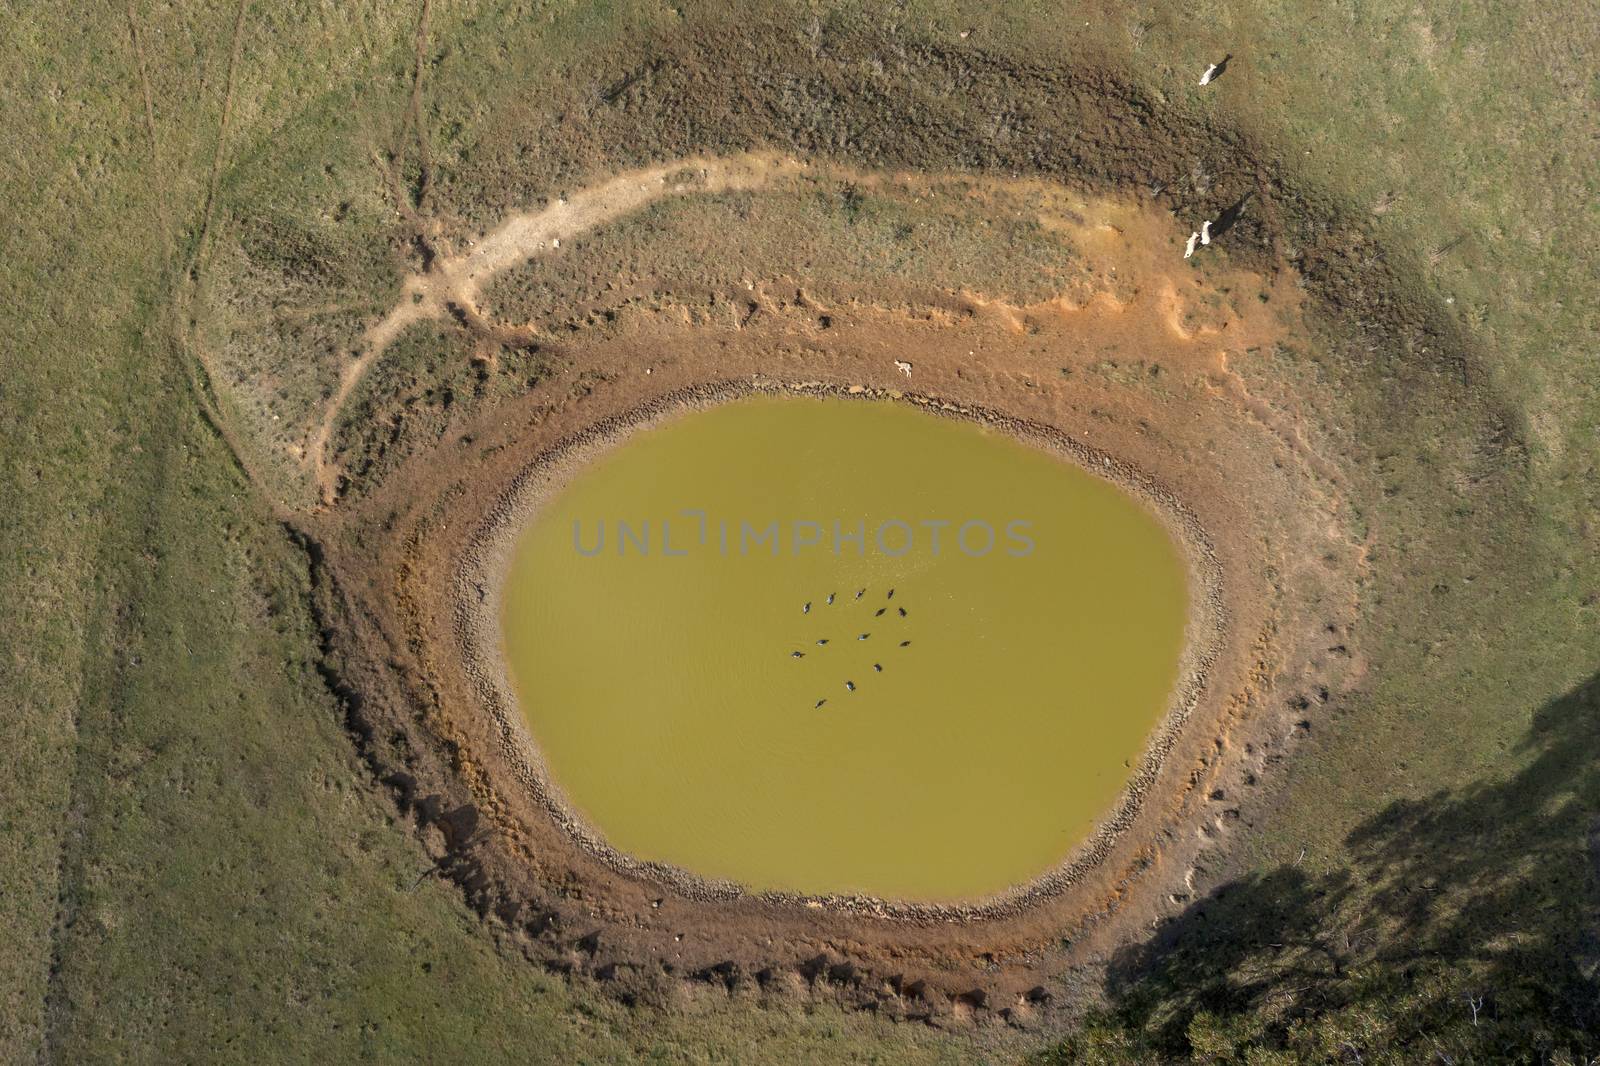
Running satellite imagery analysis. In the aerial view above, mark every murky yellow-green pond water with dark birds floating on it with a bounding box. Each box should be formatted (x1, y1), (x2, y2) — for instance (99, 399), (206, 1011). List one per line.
(502, 399), (1187, 900)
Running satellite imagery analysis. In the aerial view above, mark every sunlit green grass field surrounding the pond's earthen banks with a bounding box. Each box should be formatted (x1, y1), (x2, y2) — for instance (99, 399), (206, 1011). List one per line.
(0, 0), (1600, 1063)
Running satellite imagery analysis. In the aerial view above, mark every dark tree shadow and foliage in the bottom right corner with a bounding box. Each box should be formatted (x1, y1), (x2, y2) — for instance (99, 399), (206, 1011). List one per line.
(1075, 674), (1600, 1063)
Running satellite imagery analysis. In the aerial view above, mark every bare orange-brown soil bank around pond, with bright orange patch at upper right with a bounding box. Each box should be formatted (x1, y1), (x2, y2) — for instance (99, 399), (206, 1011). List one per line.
(291, 168), (1365, 1024)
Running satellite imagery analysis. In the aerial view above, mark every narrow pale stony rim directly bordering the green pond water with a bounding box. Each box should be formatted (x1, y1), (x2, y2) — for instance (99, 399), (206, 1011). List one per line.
(451, 379), (1227, 922)
